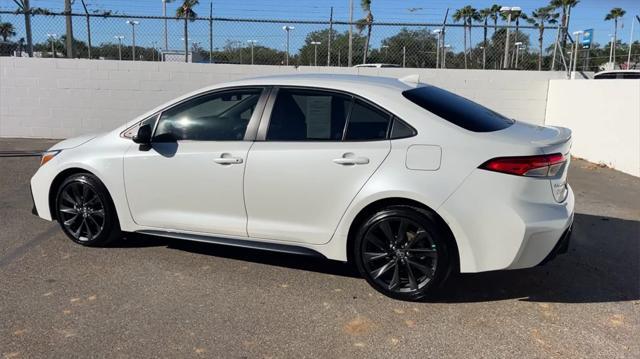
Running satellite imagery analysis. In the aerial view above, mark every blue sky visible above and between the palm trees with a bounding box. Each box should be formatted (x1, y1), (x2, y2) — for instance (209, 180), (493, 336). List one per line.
(0, 0), (640, 53)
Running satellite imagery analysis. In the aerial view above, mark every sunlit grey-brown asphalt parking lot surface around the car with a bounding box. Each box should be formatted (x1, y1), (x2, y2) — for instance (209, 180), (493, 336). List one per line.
(0, 139), (640, 358)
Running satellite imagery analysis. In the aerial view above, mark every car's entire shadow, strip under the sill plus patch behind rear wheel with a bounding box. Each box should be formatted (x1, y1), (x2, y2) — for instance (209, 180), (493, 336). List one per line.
(118, 214), (640, 303)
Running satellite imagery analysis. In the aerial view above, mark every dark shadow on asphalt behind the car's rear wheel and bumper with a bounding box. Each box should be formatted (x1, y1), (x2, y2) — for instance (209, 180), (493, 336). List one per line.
(435, 213), (640, 303)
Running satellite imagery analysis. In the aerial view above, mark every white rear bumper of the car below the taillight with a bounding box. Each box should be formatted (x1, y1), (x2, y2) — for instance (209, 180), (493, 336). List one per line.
(438, 170), (575, 273)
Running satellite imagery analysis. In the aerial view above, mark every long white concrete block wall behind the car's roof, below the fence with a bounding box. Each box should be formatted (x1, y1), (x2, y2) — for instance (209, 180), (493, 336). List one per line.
(0, 57), (563, 138)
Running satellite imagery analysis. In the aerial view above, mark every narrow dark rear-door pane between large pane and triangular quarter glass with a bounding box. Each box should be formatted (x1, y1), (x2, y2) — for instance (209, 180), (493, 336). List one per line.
(344, 99), (391, 141)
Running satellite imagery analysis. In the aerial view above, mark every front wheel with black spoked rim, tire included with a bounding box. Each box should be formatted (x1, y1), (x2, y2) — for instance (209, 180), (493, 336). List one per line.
(55, 173), (121, 247)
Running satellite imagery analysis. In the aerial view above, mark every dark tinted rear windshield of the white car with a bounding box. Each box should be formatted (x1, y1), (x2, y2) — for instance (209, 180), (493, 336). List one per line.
(402, 86), (514, 132)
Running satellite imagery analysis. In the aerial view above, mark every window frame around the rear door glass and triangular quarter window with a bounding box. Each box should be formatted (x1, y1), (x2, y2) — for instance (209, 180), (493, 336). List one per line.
(255, 85), (418, 143)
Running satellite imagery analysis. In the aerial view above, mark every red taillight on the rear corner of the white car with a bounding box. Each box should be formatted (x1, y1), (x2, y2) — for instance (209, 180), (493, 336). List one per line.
(479, 153), (566, 177)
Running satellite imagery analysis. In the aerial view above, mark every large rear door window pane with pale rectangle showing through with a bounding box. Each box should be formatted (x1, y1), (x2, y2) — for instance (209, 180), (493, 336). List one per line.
(266, 88), (351, 141)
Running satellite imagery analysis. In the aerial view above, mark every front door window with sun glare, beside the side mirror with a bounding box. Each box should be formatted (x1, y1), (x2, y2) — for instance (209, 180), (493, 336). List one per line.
(153, 89), (262, 142)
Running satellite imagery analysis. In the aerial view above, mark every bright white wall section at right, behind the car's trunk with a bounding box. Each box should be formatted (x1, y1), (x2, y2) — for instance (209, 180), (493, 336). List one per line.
(546, 80), (640, 176)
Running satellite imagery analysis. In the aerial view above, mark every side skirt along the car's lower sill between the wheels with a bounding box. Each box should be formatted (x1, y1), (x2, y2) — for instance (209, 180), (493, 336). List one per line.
(137, 230), (326, 259)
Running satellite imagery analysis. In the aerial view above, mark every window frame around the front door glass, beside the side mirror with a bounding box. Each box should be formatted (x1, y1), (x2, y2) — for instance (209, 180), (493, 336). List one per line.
(150, 85), (271, 143)
